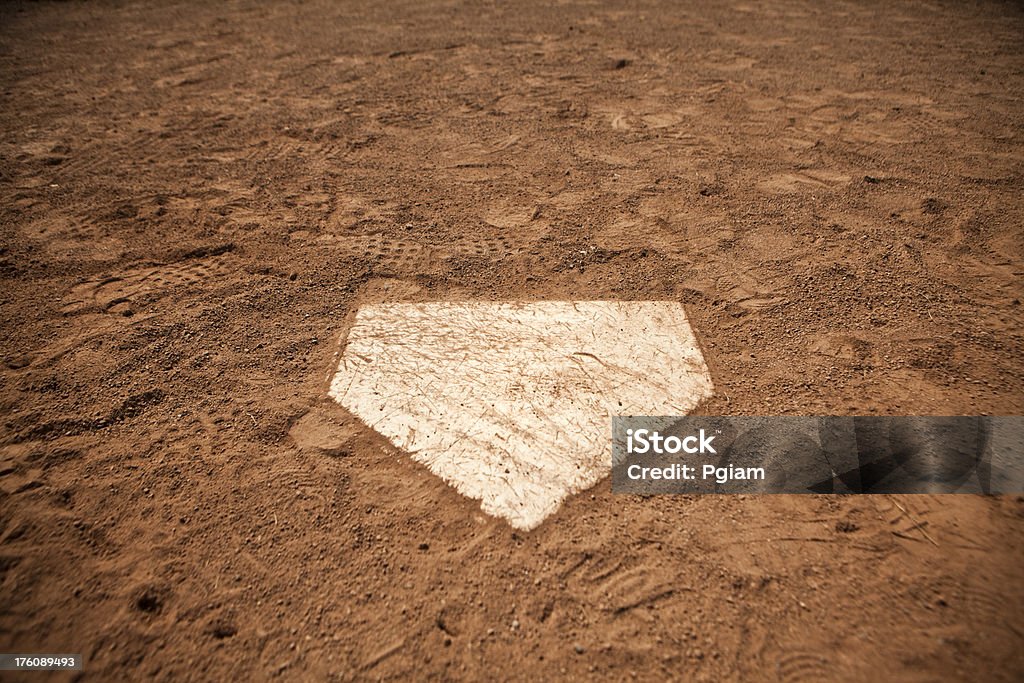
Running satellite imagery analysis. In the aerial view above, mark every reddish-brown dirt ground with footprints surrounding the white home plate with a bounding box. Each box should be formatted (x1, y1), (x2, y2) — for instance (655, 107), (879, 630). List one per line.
(0, 0), (1024, 682)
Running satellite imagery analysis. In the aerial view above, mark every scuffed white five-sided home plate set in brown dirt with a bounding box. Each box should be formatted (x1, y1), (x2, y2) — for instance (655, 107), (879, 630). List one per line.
(330, 301), (712, 529)
